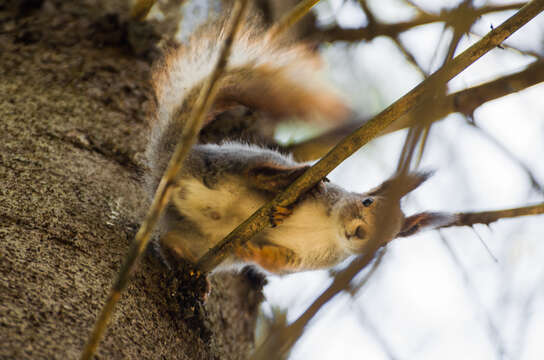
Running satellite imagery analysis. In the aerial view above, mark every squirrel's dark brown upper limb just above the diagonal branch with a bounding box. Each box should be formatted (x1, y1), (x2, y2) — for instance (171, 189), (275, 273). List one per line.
(247, 162), (310, 193)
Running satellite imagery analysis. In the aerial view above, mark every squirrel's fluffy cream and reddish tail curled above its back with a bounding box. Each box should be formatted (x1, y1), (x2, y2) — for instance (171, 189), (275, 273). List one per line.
(152, 19), (349, 131)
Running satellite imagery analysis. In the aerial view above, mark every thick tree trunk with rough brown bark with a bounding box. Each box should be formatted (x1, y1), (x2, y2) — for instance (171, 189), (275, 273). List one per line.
(0, 0), (261, 359)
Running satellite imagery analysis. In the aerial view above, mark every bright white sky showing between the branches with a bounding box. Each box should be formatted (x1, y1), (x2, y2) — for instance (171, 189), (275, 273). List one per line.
(263, 0), (544, 360)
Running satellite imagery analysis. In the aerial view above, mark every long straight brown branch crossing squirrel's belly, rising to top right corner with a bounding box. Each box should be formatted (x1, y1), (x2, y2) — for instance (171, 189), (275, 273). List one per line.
(198, 0), (544, 272)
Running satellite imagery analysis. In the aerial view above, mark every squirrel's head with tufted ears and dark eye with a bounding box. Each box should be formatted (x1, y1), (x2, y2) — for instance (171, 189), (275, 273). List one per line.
(333, 172), (452, 254)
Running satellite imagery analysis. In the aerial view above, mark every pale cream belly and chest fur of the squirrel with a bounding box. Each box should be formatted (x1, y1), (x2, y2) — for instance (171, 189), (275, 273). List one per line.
(173, 177), (340, 263)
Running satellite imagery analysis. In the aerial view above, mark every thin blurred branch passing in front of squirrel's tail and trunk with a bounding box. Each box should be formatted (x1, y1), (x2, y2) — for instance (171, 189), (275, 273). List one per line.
(77, 0), (248, 359)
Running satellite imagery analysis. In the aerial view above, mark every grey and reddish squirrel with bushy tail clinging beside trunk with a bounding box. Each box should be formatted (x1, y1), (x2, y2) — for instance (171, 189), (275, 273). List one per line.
(147, 18), (441, 274)
